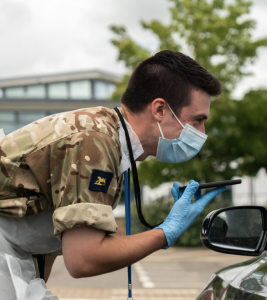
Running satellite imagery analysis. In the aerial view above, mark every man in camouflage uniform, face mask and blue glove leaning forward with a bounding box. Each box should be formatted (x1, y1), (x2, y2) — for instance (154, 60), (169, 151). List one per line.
(0, 50), (224, 299)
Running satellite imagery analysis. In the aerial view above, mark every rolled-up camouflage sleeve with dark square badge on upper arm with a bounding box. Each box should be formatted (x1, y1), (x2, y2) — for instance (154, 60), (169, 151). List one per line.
(51, 131), (121, 239)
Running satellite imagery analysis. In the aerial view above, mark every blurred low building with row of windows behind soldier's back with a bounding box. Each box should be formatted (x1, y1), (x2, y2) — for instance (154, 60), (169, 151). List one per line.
(0, 71), (119, 134)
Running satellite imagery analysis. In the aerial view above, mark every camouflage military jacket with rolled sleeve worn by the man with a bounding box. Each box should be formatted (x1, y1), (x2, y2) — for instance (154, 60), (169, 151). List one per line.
(0, 107), (127, 239)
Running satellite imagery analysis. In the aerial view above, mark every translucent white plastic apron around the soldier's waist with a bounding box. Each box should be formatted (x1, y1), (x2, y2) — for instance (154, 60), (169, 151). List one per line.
(0, 129), (61, 300)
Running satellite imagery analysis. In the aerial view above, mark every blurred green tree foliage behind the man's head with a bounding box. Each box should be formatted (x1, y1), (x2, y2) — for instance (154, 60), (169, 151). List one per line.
(110, 0), (267, 187)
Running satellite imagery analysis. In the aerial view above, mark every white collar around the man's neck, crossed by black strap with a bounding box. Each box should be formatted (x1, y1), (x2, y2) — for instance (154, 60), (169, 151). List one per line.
(115, 107), (144, 176)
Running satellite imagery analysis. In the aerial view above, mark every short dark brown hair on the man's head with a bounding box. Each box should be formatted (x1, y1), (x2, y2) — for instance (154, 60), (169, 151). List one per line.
(121, 50), (221, 115)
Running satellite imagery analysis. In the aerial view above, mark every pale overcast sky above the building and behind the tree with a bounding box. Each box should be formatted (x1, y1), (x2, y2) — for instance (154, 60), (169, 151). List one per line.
(0, 0), (267, 98)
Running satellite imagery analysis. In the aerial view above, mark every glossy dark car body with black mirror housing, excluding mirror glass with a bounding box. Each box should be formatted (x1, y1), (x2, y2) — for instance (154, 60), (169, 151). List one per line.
(197, 206), (267, 300)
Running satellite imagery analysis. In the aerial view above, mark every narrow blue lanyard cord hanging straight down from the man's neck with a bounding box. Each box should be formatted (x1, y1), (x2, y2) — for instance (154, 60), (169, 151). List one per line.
(124, 169), (132, 299)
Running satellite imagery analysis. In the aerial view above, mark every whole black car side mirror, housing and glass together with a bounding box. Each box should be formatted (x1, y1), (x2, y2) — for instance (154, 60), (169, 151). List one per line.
(200, 206), (267, 256)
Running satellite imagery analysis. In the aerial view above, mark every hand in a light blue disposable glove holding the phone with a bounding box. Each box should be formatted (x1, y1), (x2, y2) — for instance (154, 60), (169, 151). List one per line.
(154, 180), (226, 249)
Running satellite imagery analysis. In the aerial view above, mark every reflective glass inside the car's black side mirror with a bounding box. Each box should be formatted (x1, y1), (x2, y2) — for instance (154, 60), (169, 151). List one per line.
(209, 208), (263, 251)
